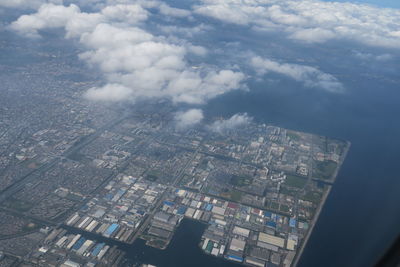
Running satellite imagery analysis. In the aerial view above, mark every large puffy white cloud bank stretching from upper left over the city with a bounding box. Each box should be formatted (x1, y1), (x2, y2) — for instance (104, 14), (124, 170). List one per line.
(10, 2), (246, 104)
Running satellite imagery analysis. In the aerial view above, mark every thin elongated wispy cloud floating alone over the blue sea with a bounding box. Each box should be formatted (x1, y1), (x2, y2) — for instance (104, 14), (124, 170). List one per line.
(250, 56), (344, 92)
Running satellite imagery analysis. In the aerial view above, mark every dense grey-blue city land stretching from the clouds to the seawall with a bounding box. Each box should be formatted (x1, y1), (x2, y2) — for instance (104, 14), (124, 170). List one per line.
(0, 37), (349, 266)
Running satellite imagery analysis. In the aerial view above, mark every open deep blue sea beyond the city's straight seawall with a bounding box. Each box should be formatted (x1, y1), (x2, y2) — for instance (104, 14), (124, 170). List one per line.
(206, 73), (400, 267)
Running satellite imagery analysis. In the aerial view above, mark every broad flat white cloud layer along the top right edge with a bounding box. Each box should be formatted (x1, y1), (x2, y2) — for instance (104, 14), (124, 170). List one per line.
(193, 0), (400, 48)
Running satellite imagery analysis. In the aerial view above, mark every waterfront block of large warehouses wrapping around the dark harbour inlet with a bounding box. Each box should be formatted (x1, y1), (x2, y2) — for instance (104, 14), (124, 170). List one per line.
(147, 189), (308, 266)
